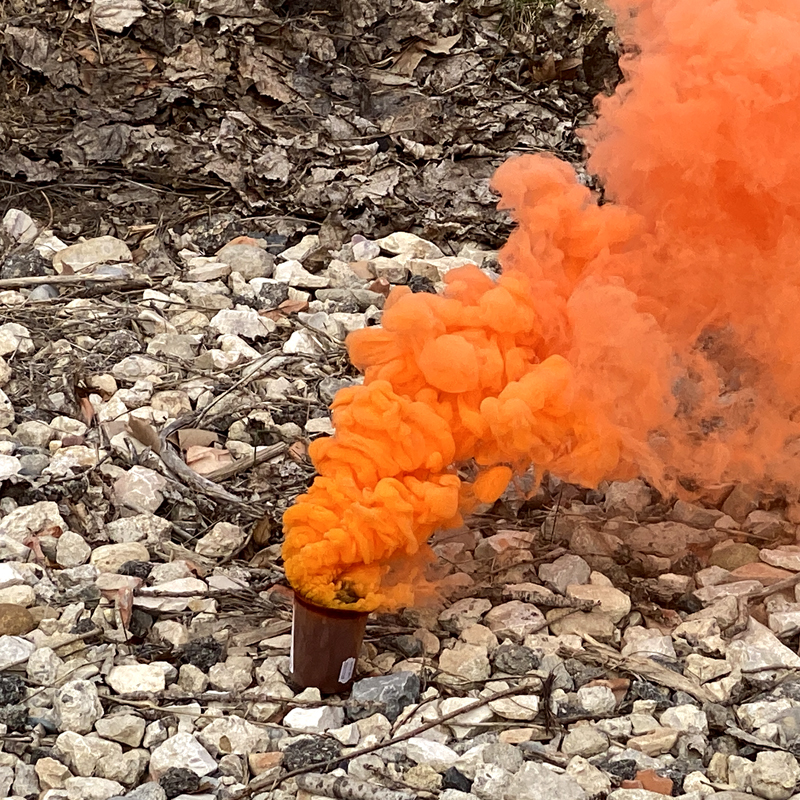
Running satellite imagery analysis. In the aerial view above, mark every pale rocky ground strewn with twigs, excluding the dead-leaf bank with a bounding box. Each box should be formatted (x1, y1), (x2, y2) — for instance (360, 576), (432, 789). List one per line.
(0, 209), (800, 800)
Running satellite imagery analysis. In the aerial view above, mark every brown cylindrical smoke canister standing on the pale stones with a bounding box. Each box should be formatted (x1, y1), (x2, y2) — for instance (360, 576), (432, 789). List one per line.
(290, 592), (369, 694)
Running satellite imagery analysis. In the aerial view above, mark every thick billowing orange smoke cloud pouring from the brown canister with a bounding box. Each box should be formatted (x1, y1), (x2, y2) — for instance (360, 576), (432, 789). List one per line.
(284, 0), (800, 610)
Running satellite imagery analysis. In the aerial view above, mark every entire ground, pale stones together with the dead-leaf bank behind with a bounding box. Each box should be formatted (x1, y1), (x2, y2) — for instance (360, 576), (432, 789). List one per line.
(0, 0), (800, 800)
